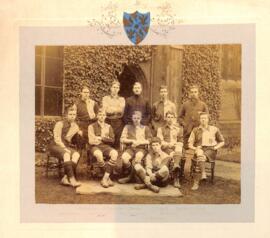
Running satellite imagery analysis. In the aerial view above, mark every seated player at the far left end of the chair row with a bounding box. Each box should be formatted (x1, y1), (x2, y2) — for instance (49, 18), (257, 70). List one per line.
(48, 108), (82, 187)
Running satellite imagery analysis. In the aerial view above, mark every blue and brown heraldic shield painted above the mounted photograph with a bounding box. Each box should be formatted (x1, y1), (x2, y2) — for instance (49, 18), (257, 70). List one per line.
(123, 11), (150, 45)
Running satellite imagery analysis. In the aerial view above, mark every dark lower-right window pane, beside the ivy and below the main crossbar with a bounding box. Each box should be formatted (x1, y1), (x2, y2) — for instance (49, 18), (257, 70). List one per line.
(44, 87), (63, 116)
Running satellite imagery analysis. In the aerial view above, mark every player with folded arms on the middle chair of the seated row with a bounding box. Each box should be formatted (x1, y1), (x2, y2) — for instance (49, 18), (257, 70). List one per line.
(118, 111), (152, 183)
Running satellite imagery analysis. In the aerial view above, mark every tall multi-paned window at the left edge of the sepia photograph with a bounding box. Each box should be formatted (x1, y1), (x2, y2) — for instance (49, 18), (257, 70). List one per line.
(35, 46), (63, 116)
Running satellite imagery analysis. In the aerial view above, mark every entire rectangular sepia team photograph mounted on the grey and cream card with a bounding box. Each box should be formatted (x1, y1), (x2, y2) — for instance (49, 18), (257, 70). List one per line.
(34, 44), (242, 204)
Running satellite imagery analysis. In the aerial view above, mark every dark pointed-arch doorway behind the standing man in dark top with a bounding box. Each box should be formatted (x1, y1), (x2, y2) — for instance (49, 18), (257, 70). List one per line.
(118, 65), (149, 99)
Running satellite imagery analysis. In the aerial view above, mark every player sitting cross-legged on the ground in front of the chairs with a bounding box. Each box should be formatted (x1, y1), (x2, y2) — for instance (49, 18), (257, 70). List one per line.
(134, 137), (171, 193)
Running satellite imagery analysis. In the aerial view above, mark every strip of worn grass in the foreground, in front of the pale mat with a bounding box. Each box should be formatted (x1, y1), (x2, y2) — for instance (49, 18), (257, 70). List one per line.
(36, 167), (241, 204)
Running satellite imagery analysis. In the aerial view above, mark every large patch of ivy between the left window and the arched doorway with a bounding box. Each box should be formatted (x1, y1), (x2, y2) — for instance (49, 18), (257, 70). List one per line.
(64, 46), (152, 109)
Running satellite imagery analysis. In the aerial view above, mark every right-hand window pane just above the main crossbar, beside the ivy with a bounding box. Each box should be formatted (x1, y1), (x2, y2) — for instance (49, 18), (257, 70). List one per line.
(45, 58), (63, 87)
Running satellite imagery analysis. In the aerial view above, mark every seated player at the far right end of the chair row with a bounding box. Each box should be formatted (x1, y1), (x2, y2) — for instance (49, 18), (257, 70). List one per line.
(188, 112), (224, 190)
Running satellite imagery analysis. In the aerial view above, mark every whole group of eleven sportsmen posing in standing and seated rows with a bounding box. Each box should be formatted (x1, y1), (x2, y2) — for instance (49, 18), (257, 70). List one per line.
(48, 80), (224, 193)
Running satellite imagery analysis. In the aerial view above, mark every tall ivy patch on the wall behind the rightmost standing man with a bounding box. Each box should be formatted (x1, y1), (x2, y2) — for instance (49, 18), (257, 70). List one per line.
(182, 45), (221, 122)
